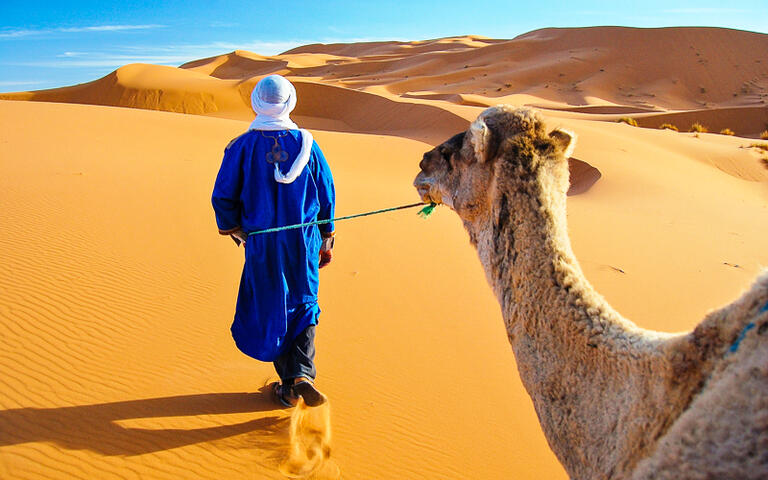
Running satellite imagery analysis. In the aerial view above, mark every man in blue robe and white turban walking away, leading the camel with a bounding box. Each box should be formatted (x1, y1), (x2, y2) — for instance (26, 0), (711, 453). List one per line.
(212, 75), (335, 406)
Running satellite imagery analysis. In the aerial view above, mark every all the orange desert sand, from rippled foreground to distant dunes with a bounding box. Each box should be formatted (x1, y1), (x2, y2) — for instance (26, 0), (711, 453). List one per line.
(0, 28), (768, 479)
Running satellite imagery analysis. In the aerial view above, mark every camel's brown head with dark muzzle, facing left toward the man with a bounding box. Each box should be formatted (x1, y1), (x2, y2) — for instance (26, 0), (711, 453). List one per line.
(414, 105), (575, 222)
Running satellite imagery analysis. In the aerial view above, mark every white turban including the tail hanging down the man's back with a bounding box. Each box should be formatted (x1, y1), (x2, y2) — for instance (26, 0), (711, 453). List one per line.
(248, 75), (314, 183)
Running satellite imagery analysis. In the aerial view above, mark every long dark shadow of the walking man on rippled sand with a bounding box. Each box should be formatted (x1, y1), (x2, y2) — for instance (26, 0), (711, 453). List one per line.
(0, 387), (289, 456)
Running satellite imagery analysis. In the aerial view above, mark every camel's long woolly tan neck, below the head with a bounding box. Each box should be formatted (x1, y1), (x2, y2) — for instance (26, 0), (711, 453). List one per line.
(466, 177), (680, 478)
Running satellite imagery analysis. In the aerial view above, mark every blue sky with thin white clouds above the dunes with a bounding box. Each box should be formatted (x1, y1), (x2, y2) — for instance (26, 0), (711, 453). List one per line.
(0, 0), (768, 92)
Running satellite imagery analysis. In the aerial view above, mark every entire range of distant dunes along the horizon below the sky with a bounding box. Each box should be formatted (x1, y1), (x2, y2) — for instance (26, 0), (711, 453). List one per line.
(6, 27), (768, 136)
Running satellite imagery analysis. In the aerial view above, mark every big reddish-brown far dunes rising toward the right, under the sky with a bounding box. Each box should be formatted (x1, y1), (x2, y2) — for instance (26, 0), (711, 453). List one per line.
(182, 27), (768, 119)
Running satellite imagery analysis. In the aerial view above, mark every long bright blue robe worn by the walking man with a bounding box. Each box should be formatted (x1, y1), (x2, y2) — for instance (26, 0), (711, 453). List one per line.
(211, 130), (336, 361)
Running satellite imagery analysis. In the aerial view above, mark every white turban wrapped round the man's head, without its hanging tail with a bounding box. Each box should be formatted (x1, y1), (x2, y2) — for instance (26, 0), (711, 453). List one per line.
(249, 75), (299, 130)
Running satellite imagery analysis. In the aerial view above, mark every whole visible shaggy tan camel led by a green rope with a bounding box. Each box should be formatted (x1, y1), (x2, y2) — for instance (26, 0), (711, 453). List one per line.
(414, 105), (768, 480)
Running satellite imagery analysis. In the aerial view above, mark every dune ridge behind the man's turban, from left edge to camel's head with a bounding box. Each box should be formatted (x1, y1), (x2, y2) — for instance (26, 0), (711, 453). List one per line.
(0, 64), (467, 141)
